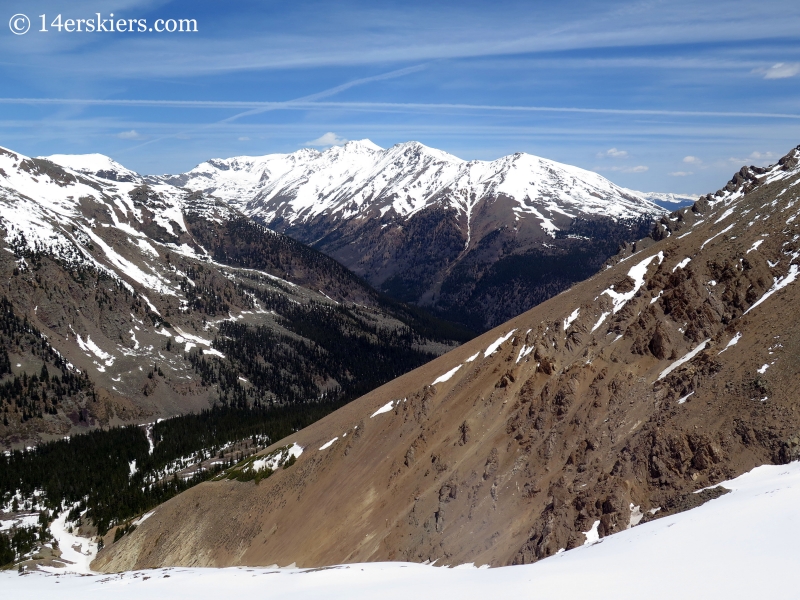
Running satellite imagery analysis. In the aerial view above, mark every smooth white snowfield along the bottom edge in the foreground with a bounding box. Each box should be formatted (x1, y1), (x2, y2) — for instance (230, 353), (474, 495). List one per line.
(14, 462), (800, 600)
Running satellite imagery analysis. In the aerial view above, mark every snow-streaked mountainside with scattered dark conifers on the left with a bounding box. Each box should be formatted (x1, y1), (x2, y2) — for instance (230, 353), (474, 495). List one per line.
(0, 148), (464, 445)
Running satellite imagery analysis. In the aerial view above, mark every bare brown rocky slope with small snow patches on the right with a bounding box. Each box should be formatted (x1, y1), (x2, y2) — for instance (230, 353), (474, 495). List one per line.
(94, 147), (800, 571)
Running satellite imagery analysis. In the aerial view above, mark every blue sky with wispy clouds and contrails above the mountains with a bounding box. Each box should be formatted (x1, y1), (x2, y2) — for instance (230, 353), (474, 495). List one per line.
(0, 0), (800, 193)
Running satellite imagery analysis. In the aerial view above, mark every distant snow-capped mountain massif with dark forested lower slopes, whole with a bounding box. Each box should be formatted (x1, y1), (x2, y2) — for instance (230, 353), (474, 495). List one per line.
(159, 140), (664, 330)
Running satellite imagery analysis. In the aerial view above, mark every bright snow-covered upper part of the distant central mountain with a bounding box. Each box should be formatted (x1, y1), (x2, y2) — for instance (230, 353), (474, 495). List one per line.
(166, 140), (659, 236)
